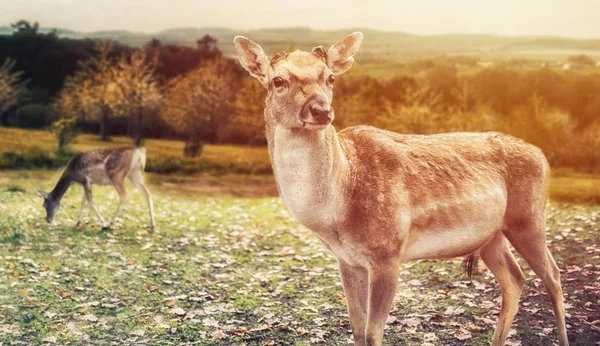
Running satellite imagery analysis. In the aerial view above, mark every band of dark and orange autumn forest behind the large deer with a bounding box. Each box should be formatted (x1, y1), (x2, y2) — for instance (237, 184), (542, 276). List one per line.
(0, 21), (600, 171)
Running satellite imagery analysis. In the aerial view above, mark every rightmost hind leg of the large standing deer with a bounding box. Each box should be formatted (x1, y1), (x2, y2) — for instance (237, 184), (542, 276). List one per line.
(505, 219), (569, 346)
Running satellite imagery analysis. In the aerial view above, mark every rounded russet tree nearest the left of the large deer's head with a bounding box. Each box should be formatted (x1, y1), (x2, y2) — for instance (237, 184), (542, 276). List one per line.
(161, 58), (239, 156)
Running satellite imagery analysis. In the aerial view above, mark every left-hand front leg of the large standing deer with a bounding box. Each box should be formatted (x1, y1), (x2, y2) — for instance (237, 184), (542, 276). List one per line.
(338, 261), (369, 346)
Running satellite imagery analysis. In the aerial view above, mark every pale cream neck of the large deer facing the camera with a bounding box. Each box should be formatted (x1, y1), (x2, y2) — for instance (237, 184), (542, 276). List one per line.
(267, 120), (348, 233)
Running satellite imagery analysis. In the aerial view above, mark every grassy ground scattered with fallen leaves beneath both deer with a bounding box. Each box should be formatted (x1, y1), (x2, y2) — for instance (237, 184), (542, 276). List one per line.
(0, 171), (600, 345)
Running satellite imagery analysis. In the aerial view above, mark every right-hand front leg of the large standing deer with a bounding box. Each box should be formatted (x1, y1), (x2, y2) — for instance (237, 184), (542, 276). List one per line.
(365, 262), (400, 346)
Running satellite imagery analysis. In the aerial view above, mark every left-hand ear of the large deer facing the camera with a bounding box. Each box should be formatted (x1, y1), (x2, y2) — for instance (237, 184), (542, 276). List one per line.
(233, 36), (269, 88)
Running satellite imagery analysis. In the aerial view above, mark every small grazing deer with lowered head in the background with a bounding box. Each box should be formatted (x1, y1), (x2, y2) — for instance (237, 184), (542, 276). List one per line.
(39, 148), (156, 230)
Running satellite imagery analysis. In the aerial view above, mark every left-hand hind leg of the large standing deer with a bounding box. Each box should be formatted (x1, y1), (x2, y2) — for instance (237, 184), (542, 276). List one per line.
(480, 233), (525, 346)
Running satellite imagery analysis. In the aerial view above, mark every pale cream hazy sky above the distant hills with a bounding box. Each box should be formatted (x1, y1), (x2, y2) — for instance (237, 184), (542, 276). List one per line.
(0, 0), (600, 38)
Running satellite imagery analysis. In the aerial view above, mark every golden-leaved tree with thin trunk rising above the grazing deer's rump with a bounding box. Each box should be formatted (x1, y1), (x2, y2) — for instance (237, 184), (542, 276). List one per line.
(111, 47), (162, 147)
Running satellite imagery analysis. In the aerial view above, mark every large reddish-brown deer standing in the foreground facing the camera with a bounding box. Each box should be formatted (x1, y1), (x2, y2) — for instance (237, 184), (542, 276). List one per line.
(234, 32), (568, 346)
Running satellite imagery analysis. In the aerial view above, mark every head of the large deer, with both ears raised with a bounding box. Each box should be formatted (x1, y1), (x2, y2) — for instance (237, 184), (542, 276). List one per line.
(233, 32), (363, 130)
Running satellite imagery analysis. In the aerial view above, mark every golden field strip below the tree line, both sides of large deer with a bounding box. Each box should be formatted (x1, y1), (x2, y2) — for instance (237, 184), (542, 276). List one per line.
(0, 127), (600, 203)
